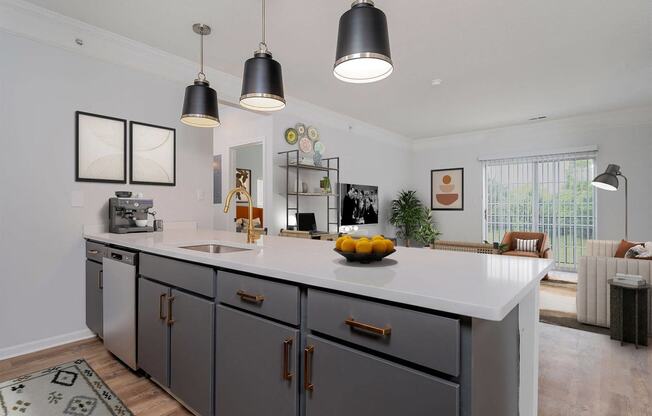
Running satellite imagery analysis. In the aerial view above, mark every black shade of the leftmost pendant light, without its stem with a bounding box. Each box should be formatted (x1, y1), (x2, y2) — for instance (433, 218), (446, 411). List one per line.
(181, 79), (220, 128)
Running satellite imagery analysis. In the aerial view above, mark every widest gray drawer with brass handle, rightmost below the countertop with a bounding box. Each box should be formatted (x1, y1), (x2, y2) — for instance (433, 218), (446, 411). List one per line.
(308, 289), (460, 376)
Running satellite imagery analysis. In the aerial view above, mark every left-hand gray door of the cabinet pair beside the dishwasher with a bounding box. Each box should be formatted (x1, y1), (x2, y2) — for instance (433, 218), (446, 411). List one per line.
(137, 277), (170, 386)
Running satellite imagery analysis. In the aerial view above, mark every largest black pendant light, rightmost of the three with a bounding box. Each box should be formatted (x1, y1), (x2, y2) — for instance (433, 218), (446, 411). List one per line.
(333, 0), (394, 83)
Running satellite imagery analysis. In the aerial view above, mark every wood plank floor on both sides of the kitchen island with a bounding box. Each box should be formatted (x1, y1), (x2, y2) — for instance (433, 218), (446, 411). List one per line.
(0, 324), (652, 416)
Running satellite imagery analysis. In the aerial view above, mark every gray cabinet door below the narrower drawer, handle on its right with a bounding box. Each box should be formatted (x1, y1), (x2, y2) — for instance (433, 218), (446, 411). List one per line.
(215, 305), (299, 416)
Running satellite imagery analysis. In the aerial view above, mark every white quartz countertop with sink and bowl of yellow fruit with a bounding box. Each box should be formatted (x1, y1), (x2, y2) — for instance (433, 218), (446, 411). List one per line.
(84, 229), (552, 321)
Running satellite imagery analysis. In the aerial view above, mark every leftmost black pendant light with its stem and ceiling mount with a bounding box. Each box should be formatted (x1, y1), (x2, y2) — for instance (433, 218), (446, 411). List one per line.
(181, 23), (220, 127)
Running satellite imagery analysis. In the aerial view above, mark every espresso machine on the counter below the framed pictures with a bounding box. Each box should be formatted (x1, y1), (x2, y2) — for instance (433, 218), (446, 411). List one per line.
(109, 197), (154, 234)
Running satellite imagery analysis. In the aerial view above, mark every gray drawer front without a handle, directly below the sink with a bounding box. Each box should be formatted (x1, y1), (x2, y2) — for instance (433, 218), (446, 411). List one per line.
(140, 253), (215, 298)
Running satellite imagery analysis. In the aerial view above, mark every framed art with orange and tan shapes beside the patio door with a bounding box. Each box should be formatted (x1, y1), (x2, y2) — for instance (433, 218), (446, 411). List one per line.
(430, 168), (464, 211)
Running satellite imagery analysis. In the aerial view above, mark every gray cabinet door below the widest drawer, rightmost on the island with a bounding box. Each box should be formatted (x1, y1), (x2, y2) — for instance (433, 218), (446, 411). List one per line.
(303, 336), (459, 416)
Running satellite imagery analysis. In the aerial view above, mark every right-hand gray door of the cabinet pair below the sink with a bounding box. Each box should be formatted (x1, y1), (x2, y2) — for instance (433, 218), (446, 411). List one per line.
(168, 289), (215, 415)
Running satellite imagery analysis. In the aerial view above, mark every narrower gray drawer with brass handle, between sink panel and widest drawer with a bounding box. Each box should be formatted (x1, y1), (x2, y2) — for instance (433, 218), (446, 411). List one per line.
(217, 272), (299, 325)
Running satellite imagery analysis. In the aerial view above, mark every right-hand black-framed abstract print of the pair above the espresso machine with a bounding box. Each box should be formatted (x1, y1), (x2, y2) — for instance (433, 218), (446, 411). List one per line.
(129, 121), (177, 186)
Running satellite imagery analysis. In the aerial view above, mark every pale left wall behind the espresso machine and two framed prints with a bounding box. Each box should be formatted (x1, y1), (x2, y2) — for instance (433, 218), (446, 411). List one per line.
(0, 32), (213, 357)
